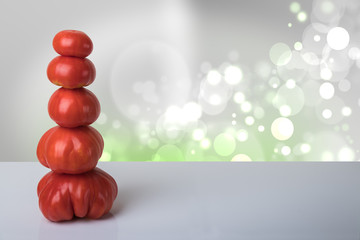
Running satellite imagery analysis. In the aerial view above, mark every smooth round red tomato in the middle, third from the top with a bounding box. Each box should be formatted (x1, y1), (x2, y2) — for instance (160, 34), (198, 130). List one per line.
(48, 88), (100, 128)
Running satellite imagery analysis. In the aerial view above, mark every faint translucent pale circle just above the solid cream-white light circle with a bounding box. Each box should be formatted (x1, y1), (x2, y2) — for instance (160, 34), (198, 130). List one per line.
(273, 86), (305, 116)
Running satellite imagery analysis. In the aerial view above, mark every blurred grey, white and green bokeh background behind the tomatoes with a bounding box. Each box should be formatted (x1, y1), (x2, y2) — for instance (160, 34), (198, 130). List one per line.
(0, 0), (360, 161)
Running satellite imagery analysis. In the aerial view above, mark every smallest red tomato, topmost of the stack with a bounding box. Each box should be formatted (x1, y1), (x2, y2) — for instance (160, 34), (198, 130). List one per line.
(53, 30), (93, 58)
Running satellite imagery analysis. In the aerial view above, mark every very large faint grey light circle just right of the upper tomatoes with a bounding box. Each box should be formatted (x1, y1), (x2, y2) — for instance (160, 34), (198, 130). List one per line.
(110, 41), (191, 123)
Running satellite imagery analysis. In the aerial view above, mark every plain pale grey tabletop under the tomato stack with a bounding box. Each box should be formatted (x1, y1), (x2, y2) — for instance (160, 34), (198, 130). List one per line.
(0, 162), (360, 240)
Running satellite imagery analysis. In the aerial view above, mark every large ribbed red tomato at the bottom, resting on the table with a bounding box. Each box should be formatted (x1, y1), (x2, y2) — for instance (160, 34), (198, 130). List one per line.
(37, 168), (118, 222)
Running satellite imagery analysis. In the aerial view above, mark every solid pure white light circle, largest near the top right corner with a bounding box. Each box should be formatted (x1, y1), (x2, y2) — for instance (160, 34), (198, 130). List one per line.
(326, 27), (350, 50)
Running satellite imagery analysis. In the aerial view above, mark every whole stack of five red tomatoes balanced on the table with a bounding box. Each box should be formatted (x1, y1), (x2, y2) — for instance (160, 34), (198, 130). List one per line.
(37, 30), (117, 221)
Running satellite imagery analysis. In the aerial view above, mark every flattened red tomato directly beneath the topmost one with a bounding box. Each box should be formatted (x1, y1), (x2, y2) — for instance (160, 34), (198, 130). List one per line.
(47, 56), (96, 88)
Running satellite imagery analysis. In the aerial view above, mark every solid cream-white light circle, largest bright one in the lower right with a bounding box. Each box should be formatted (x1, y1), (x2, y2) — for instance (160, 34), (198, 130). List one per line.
(271, 117), (294, 141)
